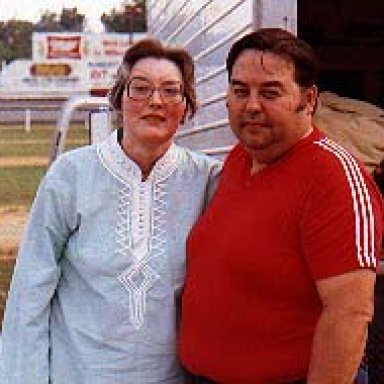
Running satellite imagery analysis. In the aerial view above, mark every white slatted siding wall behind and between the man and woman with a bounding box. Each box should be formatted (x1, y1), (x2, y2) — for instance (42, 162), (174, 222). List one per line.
(147, 0), (297, 156)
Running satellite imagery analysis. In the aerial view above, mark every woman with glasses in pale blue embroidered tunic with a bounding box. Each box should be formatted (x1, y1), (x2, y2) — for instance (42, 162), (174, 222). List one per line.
(1, 39), (220, 384)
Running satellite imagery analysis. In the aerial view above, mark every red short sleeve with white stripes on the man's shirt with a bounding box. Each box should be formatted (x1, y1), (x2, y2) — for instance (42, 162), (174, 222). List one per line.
(300, 139), (382, 280)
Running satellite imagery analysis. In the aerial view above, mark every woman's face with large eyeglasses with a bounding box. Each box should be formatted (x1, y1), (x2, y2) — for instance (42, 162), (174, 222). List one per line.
(122, 57), (186, 148)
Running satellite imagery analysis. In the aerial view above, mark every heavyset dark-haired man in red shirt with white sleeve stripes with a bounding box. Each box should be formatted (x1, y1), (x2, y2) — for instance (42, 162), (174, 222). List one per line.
(180, 29), (382, 384)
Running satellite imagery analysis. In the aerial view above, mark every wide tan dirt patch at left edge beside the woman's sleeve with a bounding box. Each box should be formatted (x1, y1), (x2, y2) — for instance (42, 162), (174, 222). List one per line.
(0, 207), (28, 259)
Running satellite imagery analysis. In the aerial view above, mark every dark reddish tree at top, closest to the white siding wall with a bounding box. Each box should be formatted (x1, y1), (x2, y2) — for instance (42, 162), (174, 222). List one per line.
(100, 0), (147, 32)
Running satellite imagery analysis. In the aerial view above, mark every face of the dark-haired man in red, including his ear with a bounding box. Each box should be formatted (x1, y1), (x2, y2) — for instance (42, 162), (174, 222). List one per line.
(227, 49), (316, 163)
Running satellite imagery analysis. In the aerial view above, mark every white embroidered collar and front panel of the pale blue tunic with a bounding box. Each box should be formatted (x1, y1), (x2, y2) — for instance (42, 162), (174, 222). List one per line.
(98, 130), (178, 329)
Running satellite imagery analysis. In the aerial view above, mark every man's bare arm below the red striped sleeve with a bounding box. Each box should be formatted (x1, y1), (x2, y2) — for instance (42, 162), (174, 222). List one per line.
(308, 270), (375, 384)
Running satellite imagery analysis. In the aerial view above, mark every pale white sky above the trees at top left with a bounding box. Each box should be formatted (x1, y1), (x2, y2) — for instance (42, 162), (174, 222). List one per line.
(0, 0), (129, 32)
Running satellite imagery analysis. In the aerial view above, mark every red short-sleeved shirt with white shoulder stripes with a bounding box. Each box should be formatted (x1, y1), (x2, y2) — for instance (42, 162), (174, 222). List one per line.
(180, 130), (382, 384)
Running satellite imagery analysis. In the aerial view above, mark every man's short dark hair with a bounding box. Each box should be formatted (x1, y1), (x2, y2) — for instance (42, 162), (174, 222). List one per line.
(227, 28), (318, 87)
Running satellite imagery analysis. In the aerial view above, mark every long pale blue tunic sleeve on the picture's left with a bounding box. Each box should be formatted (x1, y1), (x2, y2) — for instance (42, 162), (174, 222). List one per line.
(0, 160), (76, 384)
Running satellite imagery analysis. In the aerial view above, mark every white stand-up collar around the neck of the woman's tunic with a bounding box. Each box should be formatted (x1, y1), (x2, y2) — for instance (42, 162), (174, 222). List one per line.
(97, 131), (180, 184)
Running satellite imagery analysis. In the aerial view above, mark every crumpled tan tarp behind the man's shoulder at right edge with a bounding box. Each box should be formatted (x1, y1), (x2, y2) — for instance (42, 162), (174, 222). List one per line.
(314, 92), (384, 172)
